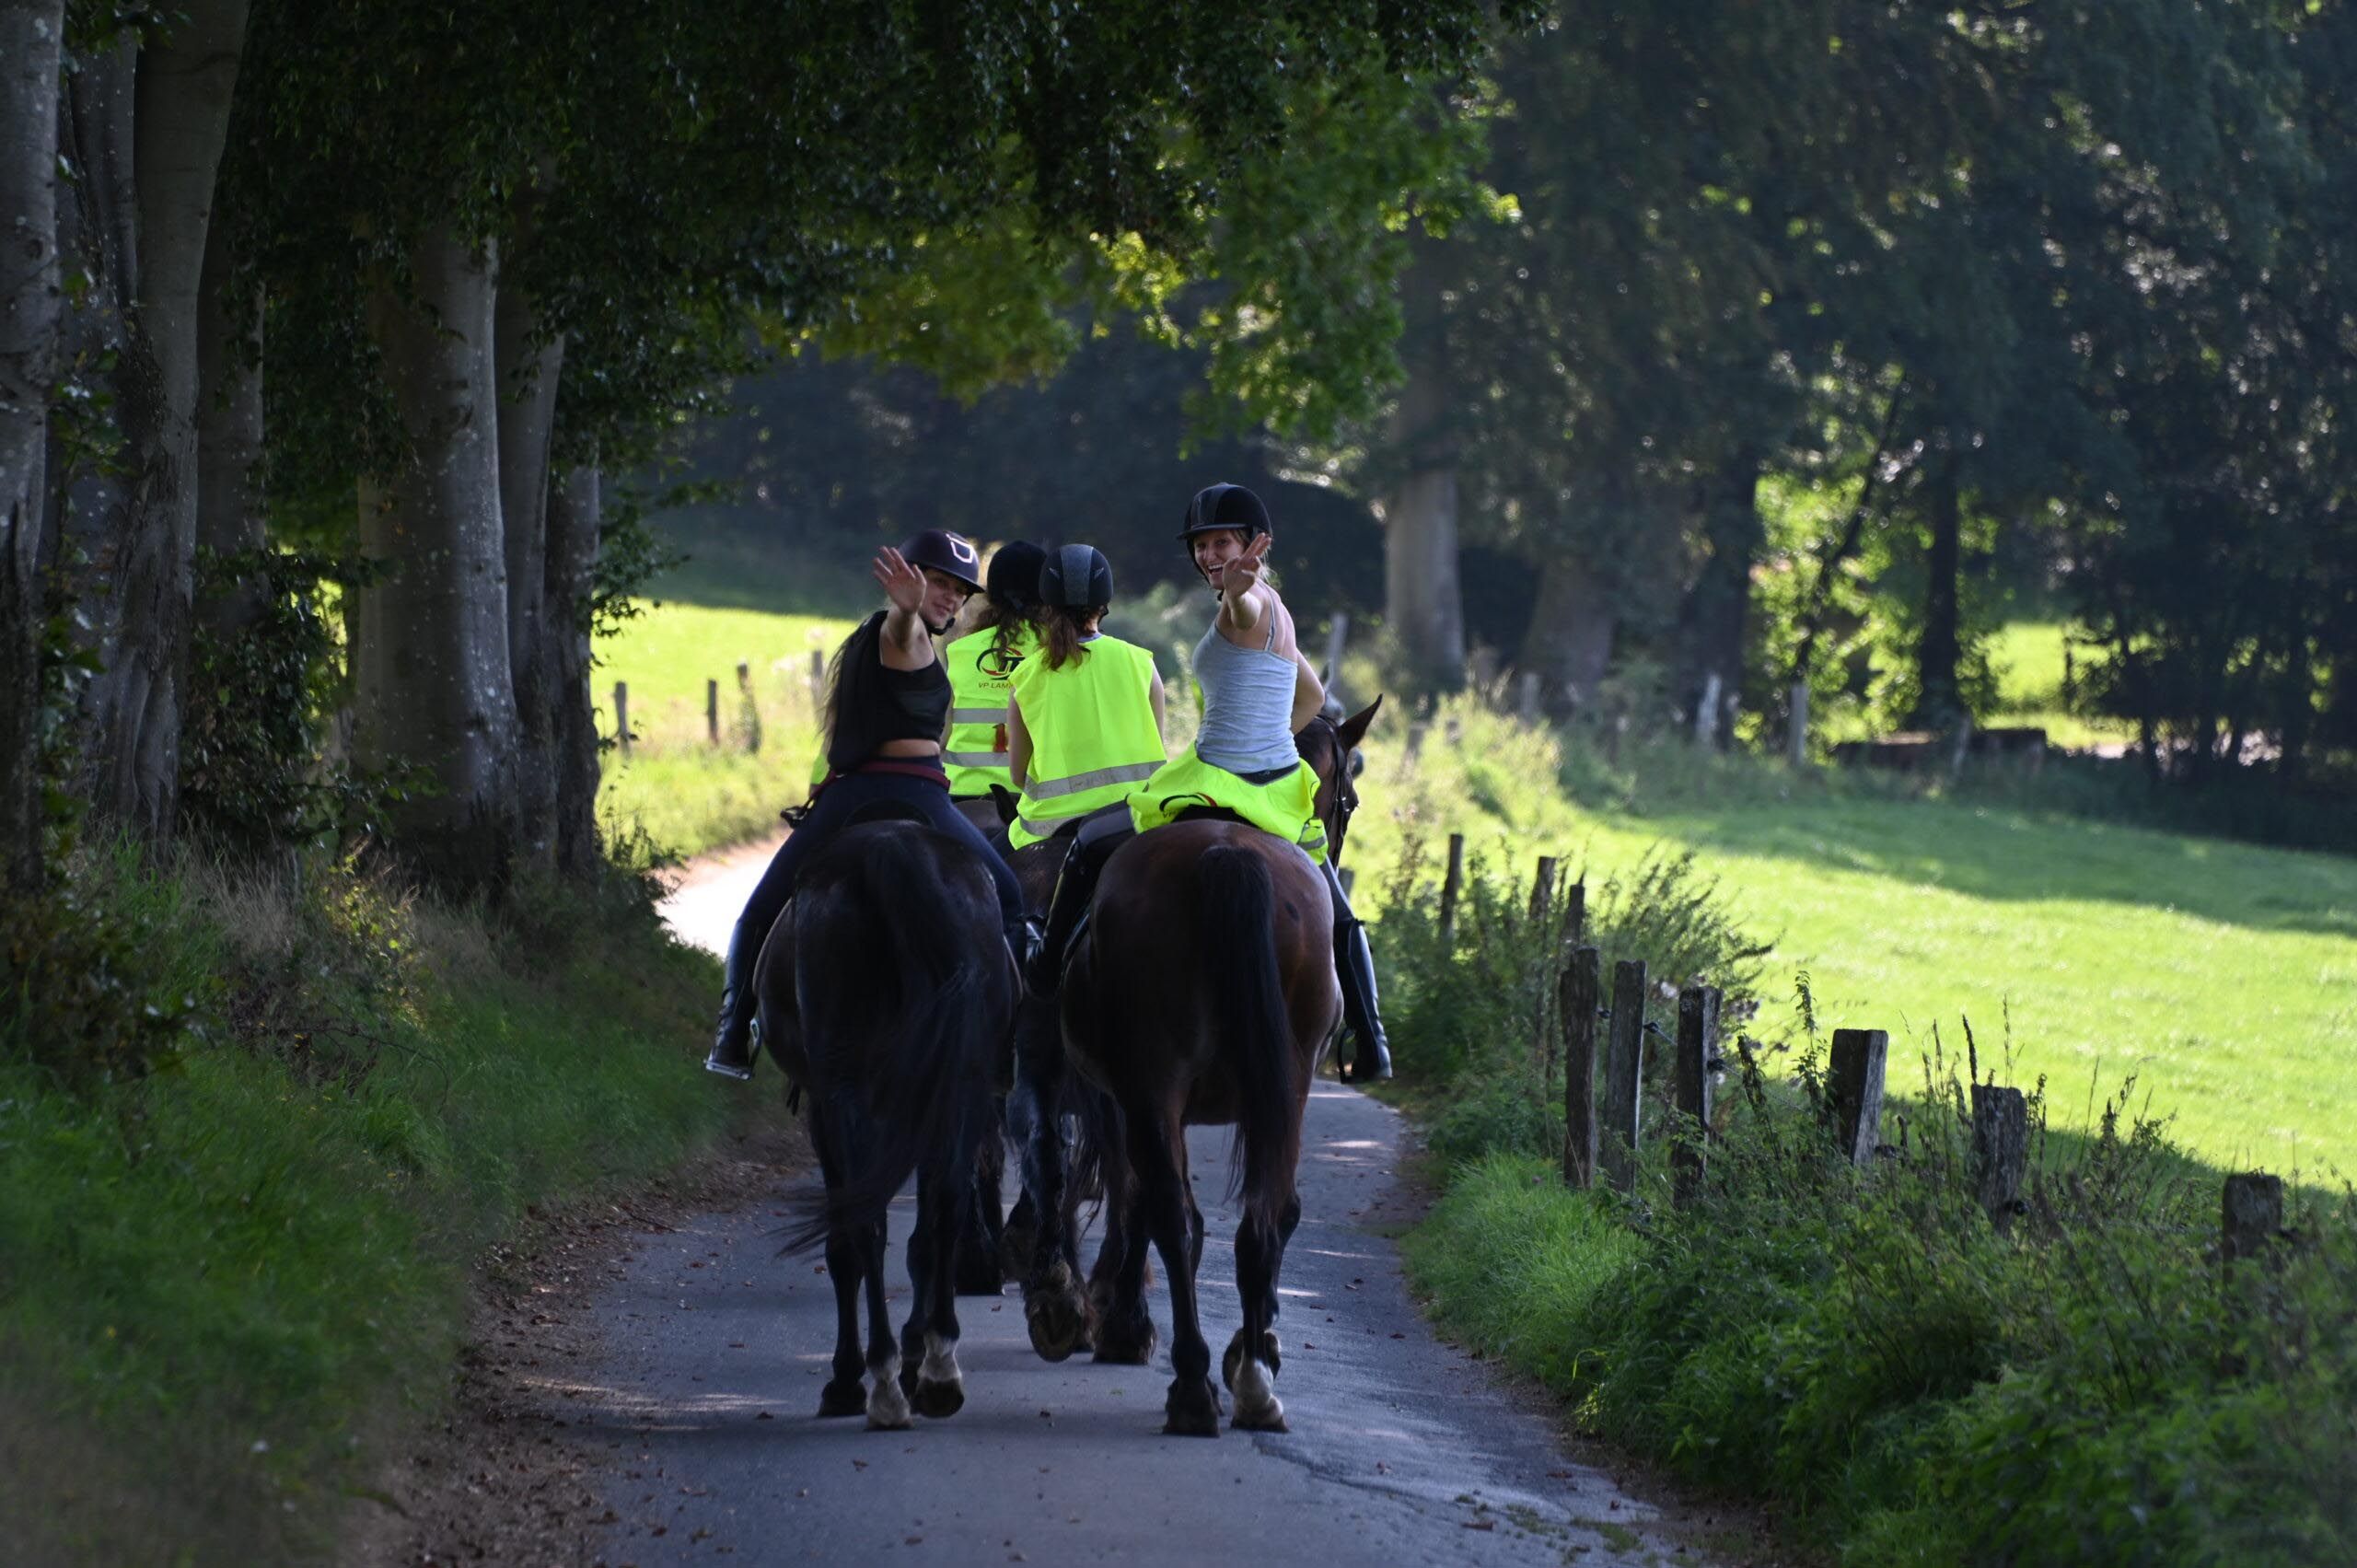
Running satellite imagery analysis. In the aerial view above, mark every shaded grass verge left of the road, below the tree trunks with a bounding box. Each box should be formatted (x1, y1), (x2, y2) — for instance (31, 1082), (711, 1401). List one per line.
(0, 854), (733, 1563)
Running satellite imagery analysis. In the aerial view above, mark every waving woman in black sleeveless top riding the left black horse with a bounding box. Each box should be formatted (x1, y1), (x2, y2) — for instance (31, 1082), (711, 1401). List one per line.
(704, 528), (1028, 1077)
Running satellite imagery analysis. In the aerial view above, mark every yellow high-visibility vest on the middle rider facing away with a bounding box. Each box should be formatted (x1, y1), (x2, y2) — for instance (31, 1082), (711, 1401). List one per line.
(1006, 636), (1162, 849)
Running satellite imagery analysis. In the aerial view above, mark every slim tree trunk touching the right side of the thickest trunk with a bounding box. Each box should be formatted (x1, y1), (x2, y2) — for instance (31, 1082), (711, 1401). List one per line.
(493, 287), (565, 861)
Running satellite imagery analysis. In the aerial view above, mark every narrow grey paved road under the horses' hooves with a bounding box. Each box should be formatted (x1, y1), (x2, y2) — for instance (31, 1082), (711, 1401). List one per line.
(575, 843), (1700, 1568)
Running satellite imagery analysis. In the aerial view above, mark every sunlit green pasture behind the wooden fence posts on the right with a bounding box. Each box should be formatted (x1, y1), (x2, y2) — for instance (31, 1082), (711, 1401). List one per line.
(1351, 703), (2357, 1179)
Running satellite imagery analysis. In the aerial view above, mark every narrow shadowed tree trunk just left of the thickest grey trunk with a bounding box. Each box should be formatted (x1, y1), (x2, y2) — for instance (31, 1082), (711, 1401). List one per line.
(195, 207), (266, 636)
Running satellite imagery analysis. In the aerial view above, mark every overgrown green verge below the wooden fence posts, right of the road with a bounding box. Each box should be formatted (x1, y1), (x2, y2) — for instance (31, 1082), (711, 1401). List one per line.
(1407, 1032), (2357, 1568)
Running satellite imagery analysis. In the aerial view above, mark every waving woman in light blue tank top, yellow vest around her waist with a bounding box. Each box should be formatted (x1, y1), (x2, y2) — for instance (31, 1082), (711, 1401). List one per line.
(1026, 483), (1390, 1080)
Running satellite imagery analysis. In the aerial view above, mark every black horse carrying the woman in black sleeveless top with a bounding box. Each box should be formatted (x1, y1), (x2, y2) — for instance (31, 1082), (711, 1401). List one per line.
(754, 820), (1016, 1426)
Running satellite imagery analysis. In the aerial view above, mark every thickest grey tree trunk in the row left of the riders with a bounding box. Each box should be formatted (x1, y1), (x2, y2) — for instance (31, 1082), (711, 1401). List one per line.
(354, 231), (517, 889)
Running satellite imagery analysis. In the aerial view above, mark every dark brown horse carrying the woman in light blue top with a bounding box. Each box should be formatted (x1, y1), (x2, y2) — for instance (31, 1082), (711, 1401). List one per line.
(1063, 701), (1381, 1436)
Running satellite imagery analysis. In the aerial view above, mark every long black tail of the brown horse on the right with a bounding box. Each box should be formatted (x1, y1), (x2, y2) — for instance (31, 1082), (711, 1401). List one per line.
(1195, 844), (1301, 1226)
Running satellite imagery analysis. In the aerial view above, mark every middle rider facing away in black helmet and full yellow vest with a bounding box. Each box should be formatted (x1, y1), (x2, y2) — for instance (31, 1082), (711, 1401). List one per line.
(1006, 545), (1162, 849)
